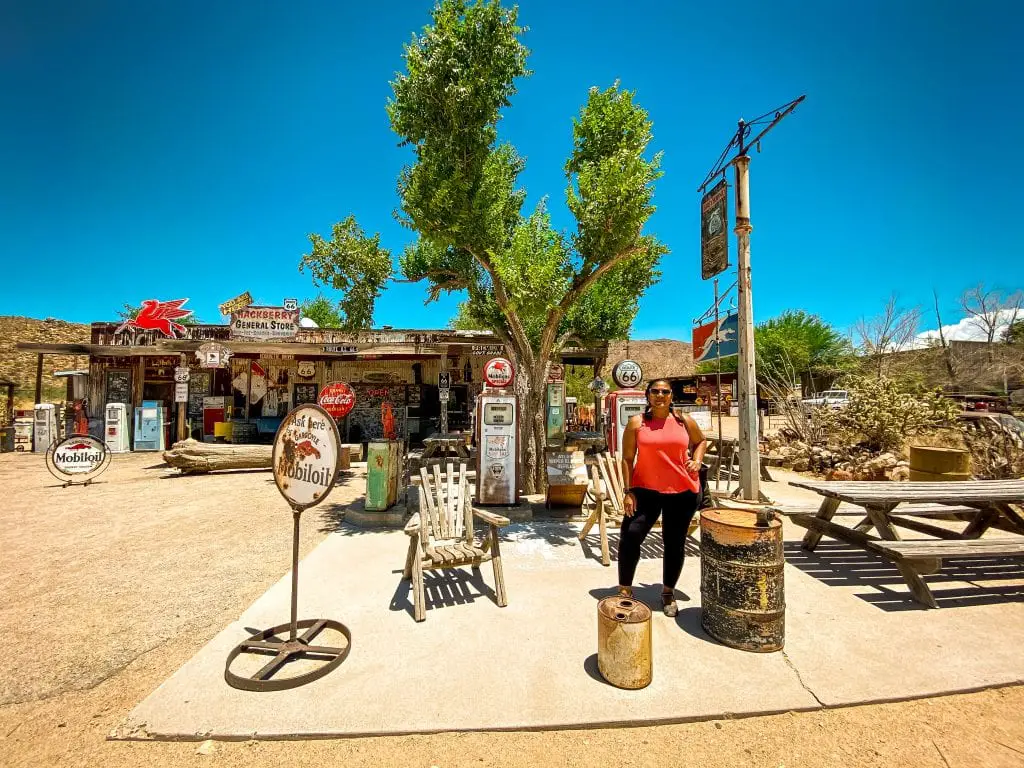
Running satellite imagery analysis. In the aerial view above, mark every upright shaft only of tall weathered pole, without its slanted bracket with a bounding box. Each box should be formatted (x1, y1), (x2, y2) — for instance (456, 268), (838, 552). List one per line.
(734, 148), (761, 502)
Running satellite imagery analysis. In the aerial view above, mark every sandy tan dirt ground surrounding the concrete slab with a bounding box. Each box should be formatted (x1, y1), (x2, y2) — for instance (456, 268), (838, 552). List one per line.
(0, 454), (1024, 768)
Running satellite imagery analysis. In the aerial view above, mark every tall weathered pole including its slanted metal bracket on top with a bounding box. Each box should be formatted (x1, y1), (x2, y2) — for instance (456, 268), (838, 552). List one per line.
(700, 96), (805, 502)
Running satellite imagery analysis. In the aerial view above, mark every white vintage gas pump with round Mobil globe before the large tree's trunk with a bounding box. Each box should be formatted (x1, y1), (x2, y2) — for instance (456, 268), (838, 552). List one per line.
(475, 357), (519, 505)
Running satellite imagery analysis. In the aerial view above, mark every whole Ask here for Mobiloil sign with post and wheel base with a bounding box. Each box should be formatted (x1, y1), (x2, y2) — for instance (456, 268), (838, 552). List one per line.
(224, 403), (352, 691)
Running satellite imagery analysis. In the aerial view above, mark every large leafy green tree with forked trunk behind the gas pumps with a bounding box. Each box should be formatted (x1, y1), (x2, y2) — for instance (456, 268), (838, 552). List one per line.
(301, 0), (667, 492)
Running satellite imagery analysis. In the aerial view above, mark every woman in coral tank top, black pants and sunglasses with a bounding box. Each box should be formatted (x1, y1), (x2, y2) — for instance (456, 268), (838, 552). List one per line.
(618, 379), (708, 616)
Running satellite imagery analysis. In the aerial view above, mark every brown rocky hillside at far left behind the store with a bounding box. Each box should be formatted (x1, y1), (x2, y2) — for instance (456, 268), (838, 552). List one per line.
(0, 315), (89, 417)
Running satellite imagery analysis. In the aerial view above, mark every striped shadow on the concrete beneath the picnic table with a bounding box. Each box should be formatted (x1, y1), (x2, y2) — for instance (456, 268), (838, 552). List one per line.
(783, 541), (1024, 611)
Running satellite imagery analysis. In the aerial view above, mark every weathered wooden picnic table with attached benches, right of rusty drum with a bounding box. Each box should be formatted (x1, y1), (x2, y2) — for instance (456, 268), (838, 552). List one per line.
(778, 480), (1024, 608)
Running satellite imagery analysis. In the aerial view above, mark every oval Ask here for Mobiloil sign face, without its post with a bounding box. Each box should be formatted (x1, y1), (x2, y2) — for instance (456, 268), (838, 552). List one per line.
(272, 403), (341, 511)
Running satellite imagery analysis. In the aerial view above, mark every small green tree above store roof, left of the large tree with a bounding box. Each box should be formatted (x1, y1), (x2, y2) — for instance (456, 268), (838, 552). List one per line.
(299, 216), (392, 331)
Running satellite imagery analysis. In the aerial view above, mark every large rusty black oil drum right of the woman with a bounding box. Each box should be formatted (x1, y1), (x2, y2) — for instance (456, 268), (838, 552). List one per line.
(700, 509), (785, 653)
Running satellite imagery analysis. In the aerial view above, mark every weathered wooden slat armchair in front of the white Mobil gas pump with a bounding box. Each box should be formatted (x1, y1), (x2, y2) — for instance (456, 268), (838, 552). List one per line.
(402, 462), (509, 622)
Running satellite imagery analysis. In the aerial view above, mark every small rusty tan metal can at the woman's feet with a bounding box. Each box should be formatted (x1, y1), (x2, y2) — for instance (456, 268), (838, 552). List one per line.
(597, 596), (653, 688)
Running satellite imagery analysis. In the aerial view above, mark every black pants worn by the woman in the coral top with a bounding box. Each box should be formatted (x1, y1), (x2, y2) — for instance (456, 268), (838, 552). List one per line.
(618, 488), (699, 588)
